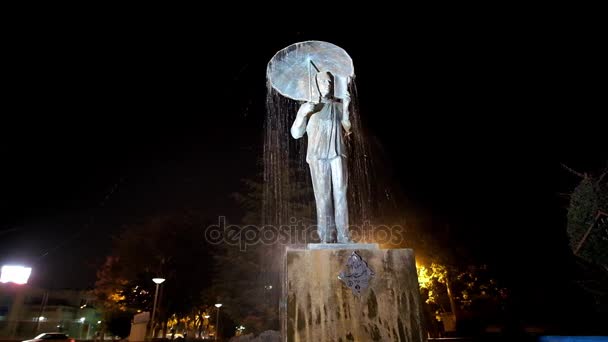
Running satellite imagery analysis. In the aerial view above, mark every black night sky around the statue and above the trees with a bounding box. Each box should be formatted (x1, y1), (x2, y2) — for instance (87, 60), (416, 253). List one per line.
(0, 24), (608, 328)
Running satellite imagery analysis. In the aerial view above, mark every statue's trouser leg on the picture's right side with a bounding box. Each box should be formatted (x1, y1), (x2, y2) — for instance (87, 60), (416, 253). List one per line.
(331, 157), (352, 243)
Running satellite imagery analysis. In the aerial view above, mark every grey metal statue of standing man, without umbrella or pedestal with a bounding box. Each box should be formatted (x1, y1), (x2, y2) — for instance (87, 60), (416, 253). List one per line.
(291, 71), (352, 243)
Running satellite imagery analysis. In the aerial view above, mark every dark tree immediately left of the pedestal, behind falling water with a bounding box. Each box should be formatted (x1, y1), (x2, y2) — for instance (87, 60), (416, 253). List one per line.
(205, 167), (314, 333)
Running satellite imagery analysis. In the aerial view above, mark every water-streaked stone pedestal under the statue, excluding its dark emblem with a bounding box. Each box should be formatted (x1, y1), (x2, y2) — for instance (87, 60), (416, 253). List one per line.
(281, 244), (426, 342)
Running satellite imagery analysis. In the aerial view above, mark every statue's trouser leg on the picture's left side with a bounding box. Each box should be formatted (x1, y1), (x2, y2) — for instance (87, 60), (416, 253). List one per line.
(309, 160), (334, 243)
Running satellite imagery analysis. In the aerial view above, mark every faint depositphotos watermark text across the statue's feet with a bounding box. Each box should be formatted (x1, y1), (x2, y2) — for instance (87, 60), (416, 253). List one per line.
(205, 216), (406, 251)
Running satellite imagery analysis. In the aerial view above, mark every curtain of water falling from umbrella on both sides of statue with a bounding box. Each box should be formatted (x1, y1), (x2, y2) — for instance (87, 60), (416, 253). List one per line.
(262, 80), (377, 232)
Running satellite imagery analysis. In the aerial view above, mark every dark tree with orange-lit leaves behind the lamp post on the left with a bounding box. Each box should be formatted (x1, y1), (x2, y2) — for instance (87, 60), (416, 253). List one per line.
(95, 214), (212, 336)
